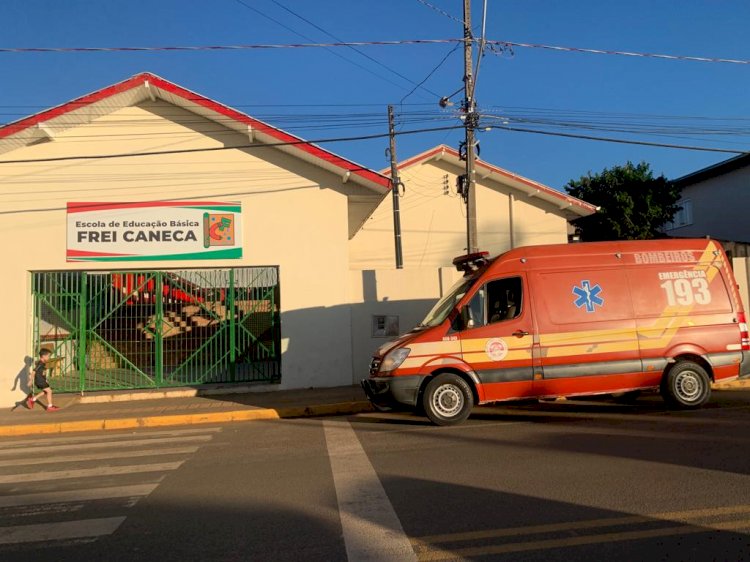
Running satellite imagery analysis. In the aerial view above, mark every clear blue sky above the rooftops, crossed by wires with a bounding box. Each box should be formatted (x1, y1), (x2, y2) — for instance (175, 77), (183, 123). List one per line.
(0, 0), (750, 189)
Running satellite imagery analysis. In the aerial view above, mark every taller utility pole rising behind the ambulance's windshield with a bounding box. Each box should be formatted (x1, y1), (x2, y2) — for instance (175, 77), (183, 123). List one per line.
(463, 0), (479, 254)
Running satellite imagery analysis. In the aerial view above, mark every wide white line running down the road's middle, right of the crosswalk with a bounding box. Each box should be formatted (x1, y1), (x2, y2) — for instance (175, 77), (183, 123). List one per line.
(323, 421), (417, 562)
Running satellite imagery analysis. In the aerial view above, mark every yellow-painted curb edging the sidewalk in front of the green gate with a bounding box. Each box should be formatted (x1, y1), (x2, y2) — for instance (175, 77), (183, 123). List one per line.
(0, 402), (372, 437)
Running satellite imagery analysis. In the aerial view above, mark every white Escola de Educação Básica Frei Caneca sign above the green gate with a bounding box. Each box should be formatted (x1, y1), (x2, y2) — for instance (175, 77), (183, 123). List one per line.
(66, 201), (242, 262)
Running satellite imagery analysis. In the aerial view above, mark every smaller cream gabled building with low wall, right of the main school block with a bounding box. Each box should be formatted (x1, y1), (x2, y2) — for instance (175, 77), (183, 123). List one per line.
(349, 145), (596, 372)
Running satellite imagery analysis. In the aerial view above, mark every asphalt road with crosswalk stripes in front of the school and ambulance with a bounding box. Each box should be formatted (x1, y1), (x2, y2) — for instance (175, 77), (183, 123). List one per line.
(0, 391), (750, 562)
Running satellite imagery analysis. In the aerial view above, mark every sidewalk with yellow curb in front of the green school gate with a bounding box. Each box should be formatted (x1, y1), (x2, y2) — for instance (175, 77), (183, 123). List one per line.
(0, 386), (372, 437)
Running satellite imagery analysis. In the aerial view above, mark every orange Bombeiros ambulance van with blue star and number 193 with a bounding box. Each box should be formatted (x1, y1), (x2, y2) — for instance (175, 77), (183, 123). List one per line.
(362, 239), (750, 425)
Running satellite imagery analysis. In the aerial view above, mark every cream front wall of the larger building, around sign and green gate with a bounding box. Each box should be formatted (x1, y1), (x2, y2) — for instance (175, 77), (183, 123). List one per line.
(0, 102), (365, 405)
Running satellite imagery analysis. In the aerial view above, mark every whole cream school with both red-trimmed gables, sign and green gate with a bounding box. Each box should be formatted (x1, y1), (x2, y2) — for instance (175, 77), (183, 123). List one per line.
(0, 73), (595, 405)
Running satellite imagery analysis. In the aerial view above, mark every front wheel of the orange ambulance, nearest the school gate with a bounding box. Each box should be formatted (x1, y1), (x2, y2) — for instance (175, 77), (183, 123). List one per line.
(422, 373), (474, 425)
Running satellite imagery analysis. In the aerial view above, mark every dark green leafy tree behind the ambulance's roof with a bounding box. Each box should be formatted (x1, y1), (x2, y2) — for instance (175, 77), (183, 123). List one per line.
(565, 162), (680, 241)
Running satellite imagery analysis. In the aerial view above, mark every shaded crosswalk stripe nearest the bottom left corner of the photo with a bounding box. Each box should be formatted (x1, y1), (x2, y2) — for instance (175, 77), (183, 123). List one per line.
(0, 517), (125, 544)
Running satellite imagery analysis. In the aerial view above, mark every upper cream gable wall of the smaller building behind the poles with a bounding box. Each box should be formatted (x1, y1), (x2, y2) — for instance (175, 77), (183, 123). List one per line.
(350, 156), (568, 269)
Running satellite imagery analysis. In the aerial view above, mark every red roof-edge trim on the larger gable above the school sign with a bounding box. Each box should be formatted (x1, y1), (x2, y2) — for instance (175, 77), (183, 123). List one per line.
(0, 72), (391, 190)
